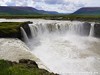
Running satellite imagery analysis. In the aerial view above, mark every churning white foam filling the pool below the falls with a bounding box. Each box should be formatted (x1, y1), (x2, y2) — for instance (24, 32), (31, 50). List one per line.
(33, 36), (100, 75)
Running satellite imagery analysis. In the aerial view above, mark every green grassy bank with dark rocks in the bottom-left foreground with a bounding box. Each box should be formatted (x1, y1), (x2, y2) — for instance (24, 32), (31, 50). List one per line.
(0, 59), (57, 75)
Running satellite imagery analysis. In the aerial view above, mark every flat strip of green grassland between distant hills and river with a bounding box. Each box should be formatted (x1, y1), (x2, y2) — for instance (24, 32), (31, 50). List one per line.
(0, 14), (100, 21)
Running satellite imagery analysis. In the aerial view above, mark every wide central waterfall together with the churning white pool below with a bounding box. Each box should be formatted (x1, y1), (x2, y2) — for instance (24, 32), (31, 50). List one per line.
(22, 20), (100, 75)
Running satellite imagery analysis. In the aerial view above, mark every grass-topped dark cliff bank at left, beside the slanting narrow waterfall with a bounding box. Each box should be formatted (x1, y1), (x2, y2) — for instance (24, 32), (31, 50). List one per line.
(0, 22), (29, 38)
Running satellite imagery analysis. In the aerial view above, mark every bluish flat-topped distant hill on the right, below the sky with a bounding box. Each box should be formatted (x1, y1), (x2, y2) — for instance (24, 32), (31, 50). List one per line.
(73, 7), (100, 15)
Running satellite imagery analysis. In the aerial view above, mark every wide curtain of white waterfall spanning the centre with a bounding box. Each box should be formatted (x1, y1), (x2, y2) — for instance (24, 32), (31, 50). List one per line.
(29, 21), (85, 37)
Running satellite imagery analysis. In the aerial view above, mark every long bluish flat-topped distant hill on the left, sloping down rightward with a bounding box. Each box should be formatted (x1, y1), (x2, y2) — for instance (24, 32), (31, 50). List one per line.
(0, 6), (58, 15)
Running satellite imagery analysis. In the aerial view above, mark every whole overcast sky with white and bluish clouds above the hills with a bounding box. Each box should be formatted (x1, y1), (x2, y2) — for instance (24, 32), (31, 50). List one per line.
(0, 0), (100, 13)
